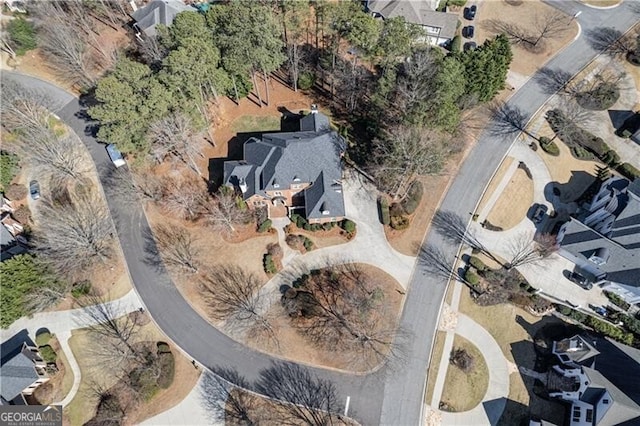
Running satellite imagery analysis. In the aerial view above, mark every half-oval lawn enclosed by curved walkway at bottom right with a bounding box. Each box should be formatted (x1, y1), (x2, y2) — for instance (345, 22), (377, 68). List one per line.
(442, 335), (489, 412)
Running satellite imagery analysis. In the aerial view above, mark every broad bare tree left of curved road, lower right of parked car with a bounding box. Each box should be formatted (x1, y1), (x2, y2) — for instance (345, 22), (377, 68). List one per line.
(35, 192), (114, 275)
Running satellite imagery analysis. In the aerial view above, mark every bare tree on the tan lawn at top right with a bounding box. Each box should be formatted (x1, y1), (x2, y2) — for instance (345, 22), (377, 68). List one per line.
(486, 10), (571, 51)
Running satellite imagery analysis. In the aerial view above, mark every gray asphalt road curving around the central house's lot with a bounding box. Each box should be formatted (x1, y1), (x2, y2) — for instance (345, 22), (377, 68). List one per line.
(3, 1), (638, 426)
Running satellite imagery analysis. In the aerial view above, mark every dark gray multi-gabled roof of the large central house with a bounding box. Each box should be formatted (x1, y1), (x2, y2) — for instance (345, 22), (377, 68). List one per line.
(224, 113), (345, 219)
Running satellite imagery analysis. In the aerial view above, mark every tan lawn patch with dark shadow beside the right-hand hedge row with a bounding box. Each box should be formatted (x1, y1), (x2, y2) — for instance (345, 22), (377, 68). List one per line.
(538, 118), (601, 203)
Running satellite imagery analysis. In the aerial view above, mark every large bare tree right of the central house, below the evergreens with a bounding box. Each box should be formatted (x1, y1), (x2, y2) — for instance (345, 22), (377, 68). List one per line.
(371, 125), (449, 200)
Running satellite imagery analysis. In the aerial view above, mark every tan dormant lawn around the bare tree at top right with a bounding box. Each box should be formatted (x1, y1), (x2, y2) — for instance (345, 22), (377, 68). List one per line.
(476, 0), (578, 76)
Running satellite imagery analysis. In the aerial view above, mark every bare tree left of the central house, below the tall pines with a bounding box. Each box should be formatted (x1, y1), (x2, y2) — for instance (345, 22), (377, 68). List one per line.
(148, 113), (204, 176)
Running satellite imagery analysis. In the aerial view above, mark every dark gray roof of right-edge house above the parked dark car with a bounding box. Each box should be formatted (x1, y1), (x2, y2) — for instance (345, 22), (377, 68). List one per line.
(560, 179), (640, 287)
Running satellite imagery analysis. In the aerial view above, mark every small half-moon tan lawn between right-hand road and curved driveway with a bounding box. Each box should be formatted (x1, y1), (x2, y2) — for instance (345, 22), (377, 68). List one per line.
(487, 168), (533, 229)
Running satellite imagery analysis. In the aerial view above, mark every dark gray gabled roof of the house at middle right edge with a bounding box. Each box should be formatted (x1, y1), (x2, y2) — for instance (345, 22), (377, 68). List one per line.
(561, 179), (640, 287)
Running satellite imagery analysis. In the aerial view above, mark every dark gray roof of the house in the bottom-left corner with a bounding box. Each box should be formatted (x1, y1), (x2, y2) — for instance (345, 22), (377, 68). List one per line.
(0, 333), (39, 401)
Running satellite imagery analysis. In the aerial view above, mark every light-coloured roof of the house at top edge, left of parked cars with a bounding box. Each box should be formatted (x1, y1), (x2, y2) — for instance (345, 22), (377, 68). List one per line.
(368, 0), (458, 39)
